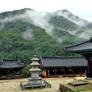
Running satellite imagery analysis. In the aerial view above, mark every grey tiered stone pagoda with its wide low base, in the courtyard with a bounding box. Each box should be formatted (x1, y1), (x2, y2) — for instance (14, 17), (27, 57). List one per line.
(20, 55), (51, 89)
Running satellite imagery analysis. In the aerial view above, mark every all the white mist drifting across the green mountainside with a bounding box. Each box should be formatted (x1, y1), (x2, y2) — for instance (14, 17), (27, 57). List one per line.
(0, 10), (92, 43)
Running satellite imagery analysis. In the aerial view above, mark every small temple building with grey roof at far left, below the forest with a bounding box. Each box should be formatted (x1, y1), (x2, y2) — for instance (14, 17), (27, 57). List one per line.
(0, 59), (26, 79)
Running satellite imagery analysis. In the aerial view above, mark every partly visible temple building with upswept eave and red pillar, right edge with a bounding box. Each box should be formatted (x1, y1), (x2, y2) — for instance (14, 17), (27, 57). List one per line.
(65, 38), (92, 77)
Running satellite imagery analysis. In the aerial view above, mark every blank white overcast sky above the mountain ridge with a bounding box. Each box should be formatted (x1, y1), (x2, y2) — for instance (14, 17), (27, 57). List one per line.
(0, 0), (92, 21)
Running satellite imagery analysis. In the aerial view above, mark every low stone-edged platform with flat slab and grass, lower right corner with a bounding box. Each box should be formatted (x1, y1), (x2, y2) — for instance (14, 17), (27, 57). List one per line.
(59, 80), (92, 92)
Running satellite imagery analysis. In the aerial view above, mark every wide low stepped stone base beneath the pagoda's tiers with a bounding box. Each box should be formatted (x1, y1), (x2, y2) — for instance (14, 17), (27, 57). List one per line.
(20, 77), (51, 90)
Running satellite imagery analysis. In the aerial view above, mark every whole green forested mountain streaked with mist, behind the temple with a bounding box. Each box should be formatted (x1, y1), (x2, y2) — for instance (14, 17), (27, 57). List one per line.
(0, 8), (92, 59)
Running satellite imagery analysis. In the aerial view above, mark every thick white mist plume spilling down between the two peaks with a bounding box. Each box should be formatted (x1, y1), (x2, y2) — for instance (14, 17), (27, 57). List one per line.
(25, 11), (62, 43)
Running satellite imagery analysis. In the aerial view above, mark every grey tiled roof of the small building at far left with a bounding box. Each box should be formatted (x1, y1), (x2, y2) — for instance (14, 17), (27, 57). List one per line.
(0, 59), (25, 69)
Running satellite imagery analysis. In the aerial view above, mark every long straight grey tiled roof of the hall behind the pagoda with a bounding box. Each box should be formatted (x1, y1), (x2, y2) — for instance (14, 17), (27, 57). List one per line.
(41, 57), (88, 67)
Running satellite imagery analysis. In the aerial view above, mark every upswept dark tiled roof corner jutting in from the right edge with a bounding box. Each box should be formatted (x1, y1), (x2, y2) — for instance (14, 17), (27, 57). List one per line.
(65, 38), (92, 53)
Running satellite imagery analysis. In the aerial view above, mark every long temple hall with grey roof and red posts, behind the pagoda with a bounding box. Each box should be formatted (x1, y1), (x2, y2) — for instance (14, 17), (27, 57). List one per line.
(40, 57), (88, 77)
